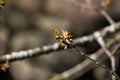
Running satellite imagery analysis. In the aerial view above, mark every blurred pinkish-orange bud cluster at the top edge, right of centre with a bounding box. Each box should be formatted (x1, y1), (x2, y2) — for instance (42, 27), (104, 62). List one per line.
(66, 0), (112, 13)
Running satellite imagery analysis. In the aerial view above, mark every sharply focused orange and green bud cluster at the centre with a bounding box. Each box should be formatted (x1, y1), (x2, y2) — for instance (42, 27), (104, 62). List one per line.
(53, 28), (73, 49)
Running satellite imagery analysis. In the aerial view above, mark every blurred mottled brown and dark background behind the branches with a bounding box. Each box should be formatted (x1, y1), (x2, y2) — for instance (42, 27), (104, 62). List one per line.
(0, 0), (120, 80)
